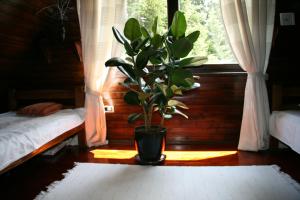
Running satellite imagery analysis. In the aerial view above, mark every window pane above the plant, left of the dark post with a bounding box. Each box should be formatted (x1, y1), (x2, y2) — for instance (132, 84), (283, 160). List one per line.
(127, 0), (168, 33)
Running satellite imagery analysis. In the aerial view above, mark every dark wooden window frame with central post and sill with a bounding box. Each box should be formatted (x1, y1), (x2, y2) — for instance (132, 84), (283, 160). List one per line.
(167, 0), (239, 73)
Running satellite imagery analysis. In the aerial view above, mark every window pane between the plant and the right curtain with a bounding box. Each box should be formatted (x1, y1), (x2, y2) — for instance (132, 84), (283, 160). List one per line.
(179, 0), (237, 64)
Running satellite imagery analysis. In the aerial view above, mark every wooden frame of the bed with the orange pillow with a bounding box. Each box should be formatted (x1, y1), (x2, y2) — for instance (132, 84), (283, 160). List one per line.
(0, 87), (86, 175)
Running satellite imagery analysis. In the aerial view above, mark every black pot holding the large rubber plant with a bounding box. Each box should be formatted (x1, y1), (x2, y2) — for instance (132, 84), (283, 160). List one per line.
(135, 126), (167, 164)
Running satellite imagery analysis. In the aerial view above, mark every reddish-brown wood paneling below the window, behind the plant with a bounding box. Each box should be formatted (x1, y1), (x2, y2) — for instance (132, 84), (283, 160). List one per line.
(104, 68), (246, 146)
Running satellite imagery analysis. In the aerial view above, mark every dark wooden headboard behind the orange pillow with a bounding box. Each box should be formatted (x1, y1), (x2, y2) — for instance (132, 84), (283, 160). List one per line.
(8, 86), (85, 110)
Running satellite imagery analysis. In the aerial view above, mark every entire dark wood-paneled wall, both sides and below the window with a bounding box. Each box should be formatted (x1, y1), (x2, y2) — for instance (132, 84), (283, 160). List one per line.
(0, 0), (300, 146)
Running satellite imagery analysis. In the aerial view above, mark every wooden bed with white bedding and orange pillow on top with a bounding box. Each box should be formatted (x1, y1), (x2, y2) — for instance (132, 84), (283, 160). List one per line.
(0, 87), (84, 174)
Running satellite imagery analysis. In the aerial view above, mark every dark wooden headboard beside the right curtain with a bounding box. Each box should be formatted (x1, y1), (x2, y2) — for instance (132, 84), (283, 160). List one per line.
(272, 84), (300, 111)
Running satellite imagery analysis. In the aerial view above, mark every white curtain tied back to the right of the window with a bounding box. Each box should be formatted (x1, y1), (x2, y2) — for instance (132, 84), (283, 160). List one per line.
(221, 0), (275, 151)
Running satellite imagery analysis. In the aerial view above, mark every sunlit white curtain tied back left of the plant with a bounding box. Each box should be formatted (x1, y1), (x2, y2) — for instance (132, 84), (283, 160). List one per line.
(77, 0), (124, 147)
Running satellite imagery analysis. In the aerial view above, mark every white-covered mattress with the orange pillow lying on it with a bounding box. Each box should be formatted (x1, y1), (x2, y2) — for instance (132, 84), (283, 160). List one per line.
(0, 108), (84, 170)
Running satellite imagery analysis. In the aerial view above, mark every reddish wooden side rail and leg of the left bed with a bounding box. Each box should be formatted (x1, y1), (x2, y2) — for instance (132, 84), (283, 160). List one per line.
(0, 123), (85, 175)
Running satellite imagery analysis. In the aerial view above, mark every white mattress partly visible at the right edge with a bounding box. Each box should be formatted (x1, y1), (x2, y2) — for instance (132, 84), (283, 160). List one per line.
(269, 110), (300, 154)
